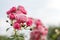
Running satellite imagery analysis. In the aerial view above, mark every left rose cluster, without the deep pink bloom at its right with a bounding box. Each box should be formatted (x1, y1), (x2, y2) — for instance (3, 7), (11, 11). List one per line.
(7, 6), (27, 30)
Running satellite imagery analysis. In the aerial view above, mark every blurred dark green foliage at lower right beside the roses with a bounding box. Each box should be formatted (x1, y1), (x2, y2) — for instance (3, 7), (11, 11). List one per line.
(48, 26), (60, 40)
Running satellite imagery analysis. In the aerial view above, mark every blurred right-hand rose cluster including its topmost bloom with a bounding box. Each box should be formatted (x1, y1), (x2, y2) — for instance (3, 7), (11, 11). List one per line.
(30, 20), (48, 40)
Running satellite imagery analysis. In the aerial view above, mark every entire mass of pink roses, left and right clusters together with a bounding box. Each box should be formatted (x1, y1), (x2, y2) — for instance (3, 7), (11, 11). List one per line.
(7, 5), (48, 40)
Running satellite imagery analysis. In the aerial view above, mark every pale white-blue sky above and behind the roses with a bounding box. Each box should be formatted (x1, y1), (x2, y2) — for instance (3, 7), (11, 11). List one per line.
(0, 0), (60, 37)
